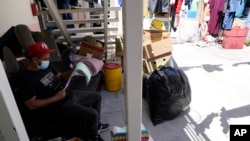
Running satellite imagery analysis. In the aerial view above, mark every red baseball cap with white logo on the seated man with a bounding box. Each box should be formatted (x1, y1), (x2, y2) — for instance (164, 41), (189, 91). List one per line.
(27, 42), (55, 57)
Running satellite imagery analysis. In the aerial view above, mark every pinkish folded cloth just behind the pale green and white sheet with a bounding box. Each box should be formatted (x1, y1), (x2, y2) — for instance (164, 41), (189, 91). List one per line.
(82, 57), (103, 76)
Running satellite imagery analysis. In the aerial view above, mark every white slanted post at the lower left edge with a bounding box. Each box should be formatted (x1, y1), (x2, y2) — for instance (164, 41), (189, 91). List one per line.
(0, 62), (29, 141)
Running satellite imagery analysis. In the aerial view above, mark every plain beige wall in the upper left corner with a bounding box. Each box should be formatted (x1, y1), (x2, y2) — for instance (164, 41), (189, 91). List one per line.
(0, 0), (40, 36)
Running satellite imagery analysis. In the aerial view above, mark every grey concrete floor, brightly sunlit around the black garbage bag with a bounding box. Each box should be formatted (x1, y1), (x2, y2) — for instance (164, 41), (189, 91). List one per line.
(98, 43), (250, 141)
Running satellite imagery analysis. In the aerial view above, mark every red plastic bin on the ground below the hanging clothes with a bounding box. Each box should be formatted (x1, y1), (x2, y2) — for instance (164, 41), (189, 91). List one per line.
(222, 27), (249, 49)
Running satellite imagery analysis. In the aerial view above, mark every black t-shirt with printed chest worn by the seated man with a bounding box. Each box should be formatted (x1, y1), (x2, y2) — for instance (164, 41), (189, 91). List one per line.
(18, 67), (63, 123)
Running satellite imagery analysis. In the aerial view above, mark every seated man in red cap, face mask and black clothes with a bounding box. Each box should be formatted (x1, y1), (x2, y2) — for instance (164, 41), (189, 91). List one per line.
(19, 42), (109, 141)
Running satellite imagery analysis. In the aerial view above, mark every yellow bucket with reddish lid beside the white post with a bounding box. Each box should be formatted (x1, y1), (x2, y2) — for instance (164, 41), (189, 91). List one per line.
(103, 63), (122, 92)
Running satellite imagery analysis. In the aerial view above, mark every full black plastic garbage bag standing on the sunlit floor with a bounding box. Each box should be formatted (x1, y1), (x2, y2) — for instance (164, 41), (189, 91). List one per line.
(147, 65), (191, 126)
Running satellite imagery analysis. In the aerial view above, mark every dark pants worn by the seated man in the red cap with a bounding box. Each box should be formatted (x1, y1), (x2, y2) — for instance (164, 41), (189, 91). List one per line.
(33, 90), (101, 140)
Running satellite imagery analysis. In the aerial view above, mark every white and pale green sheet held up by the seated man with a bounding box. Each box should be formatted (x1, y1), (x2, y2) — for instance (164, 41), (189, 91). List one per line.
(64, 62), (91, 90)
